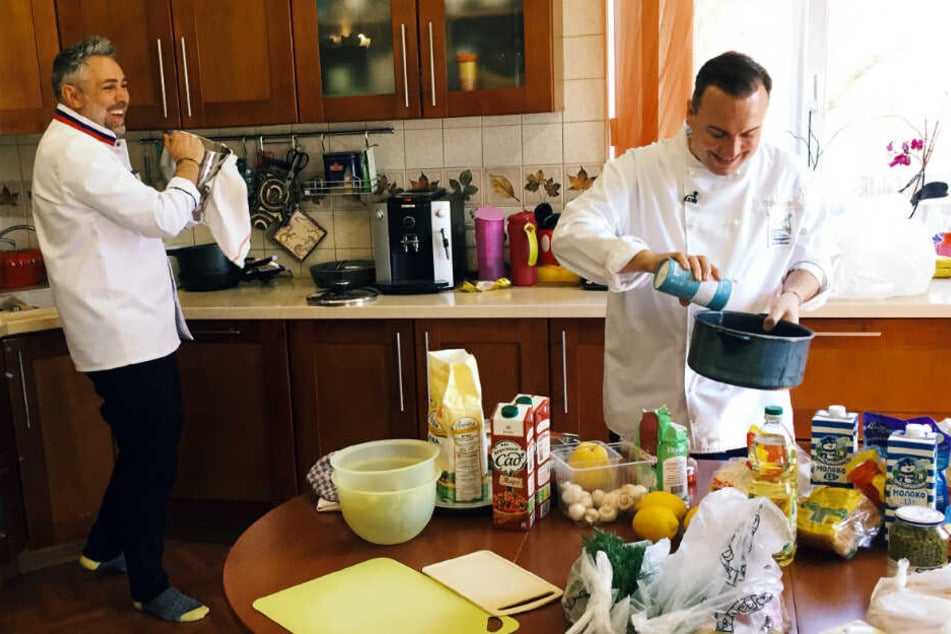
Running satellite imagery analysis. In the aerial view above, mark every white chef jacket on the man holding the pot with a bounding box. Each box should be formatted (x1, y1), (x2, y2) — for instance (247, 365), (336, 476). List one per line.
(552, 133), (836, 453)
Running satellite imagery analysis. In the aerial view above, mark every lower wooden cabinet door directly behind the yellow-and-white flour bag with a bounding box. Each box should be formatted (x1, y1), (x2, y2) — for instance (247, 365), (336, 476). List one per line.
(416, 319), (548, 438)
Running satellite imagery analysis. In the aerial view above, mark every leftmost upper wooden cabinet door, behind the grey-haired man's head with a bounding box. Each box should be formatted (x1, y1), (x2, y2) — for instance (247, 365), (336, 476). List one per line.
(0, 0), (59, 134)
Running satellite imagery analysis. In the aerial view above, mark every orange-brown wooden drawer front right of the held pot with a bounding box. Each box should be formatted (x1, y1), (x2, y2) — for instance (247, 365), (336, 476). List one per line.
(791, 319), (951, 440)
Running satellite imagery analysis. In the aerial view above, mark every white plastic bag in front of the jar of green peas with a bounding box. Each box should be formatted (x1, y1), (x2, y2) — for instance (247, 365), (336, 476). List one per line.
(865, 559), (951, 634)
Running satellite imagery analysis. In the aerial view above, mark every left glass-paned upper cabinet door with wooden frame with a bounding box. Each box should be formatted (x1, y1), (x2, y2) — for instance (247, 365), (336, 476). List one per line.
(292, 0), (420, 121)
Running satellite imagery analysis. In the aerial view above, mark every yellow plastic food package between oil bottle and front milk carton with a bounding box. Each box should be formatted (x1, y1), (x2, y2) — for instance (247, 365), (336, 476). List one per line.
(797, 485), (882, 559)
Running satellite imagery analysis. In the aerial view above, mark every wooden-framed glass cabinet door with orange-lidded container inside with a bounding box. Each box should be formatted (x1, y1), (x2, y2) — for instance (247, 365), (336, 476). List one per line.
(419, 0), (562, 117)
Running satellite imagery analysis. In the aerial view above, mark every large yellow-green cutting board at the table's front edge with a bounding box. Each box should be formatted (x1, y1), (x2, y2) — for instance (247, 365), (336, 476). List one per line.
(252, 557), (518, 634)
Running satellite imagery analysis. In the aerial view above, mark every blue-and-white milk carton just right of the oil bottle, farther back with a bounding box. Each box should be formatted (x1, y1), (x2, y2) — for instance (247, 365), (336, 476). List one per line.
(811, 405), (859, 487)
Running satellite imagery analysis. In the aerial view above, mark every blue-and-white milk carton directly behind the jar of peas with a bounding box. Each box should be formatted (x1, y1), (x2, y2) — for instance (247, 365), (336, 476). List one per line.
(885, 423), (938, 528)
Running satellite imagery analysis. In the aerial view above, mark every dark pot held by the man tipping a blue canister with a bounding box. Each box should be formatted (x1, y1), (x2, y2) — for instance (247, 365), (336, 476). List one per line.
(687, 310), (815, 390)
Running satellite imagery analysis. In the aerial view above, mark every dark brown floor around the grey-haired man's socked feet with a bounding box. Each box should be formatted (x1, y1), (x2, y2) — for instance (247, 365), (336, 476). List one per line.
(0, 528), (247, 634)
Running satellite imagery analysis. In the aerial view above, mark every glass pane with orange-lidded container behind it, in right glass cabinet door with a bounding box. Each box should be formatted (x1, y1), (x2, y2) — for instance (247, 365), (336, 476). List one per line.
(445, 0), (525, 91)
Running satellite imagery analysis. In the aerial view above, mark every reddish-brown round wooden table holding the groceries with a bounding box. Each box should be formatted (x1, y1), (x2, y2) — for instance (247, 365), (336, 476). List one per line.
(223, 462), (886, 634)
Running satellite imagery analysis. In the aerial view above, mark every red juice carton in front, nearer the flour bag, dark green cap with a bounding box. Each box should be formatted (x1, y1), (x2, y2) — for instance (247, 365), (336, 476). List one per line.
(489, 403), (535, 530)
